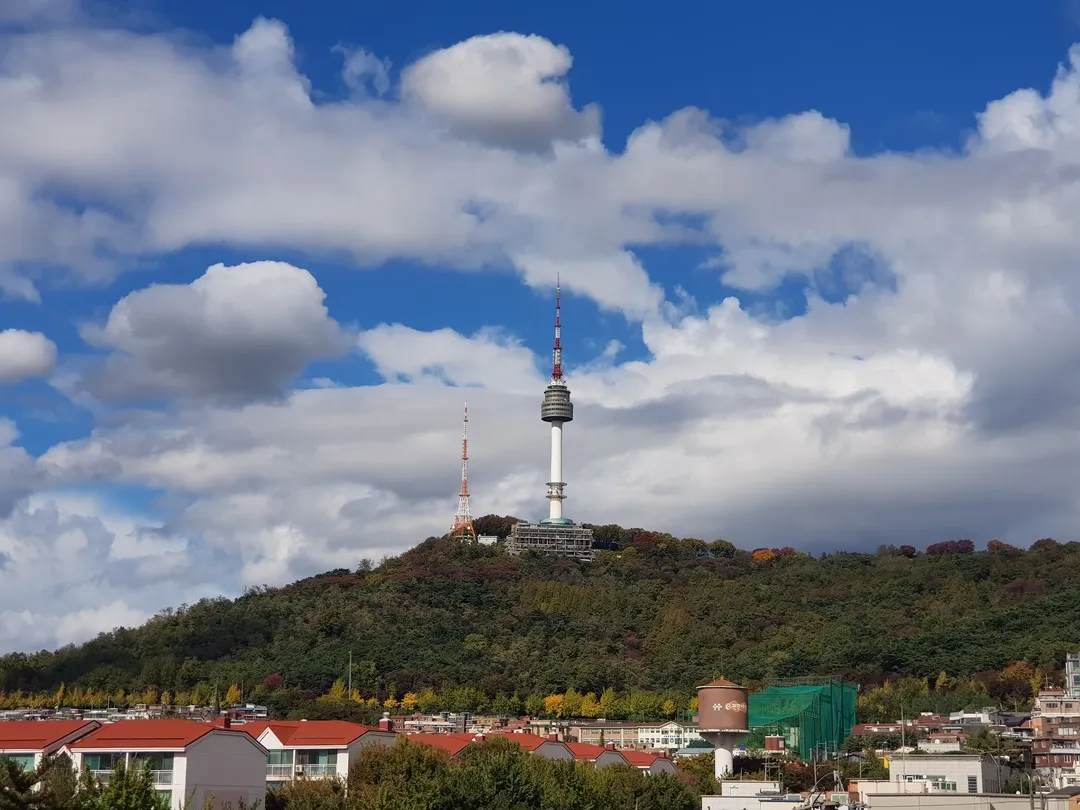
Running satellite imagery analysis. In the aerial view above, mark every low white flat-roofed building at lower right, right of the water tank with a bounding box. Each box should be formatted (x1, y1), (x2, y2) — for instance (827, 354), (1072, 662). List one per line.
(876, 754), (1012, 793)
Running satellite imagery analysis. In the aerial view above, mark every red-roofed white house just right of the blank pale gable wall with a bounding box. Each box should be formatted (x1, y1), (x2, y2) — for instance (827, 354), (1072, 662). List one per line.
(239, 720), (397, 785)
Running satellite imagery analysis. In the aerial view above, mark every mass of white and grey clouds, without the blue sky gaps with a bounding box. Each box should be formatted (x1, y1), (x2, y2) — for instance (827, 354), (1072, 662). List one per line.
(0, 18), (1080, 648)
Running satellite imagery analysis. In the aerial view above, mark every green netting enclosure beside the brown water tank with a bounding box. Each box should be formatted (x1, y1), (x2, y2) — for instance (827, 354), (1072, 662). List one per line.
(745, 680), (856, 759)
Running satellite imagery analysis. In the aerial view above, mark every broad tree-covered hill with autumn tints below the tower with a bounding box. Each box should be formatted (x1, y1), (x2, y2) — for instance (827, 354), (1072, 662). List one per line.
(0, 517), (1080, 701)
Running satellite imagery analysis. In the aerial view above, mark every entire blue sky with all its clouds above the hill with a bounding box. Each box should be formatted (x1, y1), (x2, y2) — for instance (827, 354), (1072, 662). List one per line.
(0, 0), (1080, 652)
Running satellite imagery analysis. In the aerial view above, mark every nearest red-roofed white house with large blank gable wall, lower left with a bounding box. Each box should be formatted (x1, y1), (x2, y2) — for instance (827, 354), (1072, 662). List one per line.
(65, 719), (267, 810)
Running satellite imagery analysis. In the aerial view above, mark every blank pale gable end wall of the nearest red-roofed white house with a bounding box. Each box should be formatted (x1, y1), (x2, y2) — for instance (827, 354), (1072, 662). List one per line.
(183, 731), (267, 810)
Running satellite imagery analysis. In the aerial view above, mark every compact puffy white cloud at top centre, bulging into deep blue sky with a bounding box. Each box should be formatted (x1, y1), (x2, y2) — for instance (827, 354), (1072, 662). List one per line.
(402, 31), (599, 150)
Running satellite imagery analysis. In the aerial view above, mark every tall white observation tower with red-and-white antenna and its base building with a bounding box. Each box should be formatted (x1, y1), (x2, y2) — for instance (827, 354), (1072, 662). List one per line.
(507, 281), (594, 561)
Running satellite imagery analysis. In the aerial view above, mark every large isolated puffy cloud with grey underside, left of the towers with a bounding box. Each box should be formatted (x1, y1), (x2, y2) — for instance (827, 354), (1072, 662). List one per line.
(75, 261), (348, 404)
